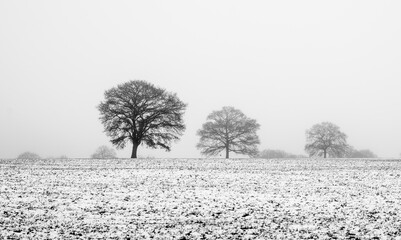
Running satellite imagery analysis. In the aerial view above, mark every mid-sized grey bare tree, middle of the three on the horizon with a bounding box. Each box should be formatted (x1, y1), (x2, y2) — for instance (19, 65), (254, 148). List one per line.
(197, 107), (260, 158)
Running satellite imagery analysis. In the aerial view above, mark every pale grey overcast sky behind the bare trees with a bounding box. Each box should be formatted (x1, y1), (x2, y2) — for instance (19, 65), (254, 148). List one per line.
(0, 0), (401, 158)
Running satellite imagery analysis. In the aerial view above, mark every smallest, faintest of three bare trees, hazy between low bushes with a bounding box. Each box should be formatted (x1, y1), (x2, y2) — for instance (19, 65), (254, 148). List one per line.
(305, 122), (349, 158)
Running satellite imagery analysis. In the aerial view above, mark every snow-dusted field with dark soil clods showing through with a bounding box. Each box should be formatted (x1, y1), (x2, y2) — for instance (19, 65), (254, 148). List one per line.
(0, 159), (401, 239)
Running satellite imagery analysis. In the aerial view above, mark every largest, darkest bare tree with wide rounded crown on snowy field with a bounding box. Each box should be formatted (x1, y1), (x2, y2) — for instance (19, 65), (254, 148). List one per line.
(98, 80), (186, 158)
